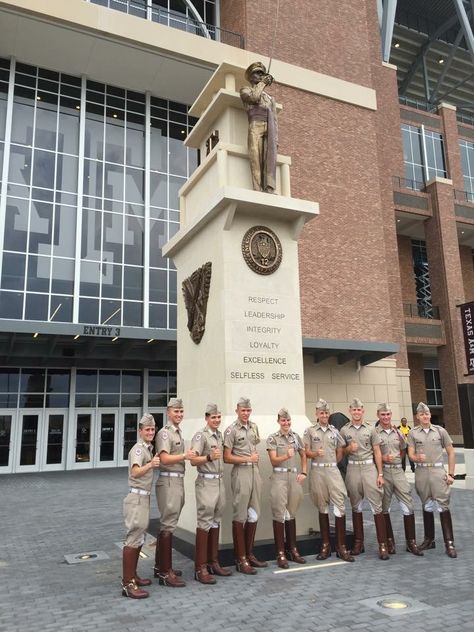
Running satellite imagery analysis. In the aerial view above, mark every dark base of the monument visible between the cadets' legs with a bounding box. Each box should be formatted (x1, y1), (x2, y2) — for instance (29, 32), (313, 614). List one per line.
(148, 518), (354, 566)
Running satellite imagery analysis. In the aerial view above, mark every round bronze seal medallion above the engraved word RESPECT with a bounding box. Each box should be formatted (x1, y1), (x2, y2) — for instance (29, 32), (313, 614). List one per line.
(242, 226), (283, 274)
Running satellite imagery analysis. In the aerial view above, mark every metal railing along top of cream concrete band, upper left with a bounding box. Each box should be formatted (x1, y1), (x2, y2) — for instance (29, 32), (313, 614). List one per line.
(85, 0), (245, 48)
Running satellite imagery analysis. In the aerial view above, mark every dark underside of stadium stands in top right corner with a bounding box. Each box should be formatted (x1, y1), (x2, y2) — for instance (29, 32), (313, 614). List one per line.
(378, 0), (474, 113)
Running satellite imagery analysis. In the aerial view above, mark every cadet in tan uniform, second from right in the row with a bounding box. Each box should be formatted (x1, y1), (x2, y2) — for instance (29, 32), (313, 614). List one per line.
(377, 403), (423, 555)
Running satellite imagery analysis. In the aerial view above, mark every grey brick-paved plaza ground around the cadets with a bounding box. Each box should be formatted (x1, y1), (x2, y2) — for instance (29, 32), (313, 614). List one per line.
(0, 455), (474, 632)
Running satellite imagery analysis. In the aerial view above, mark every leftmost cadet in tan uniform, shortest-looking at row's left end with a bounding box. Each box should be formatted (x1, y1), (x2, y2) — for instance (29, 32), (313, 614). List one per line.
(122, 414), (160, 599)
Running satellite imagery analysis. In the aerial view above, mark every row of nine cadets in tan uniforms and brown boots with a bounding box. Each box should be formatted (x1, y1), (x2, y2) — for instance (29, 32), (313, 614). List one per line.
(122, 397), (457, 599)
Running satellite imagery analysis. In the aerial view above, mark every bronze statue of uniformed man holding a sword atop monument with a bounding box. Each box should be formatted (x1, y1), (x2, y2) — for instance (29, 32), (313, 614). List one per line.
(240, 61), (278, 193)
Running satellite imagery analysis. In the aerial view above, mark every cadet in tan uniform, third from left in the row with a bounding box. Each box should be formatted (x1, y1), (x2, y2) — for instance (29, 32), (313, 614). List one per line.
(191, 404), (232, 584)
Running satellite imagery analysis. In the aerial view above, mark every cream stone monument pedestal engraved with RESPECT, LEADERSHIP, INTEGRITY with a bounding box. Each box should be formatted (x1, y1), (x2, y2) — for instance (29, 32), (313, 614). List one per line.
(163, 65), (319, 544)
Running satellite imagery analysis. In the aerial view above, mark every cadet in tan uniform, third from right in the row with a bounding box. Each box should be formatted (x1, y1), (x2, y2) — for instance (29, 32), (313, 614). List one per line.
(341, 398), (390, 560)
